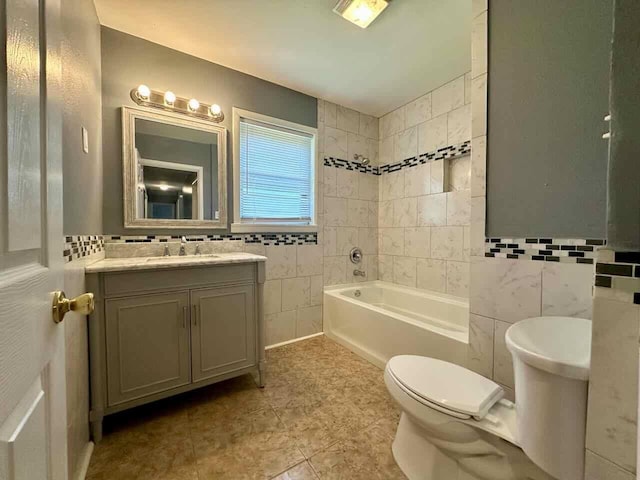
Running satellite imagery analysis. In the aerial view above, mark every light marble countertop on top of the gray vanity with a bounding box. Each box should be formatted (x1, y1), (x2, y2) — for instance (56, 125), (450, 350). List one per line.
(85, 252), (267, 273)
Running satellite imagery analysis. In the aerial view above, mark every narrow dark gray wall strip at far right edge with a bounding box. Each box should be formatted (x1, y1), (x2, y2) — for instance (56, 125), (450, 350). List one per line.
(607, 0), (640, 251)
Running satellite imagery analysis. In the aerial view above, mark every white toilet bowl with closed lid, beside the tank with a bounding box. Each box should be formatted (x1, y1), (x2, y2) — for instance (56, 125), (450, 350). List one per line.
(384, 355), (553, 480)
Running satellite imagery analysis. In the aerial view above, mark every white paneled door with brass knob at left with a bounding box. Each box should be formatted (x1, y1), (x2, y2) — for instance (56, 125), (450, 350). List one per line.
(0, 0), (67, 480)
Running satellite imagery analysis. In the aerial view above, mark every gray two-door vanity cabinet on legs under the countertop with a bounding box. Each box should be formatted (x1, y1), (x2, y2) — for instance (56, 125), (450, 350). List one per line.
(86, 254), (265, 442)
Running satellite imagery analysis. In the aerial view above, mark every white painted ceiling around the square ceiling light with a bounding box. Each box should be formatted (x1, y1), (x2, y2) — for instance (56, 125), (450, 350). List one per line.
(95, 0), (471, 117)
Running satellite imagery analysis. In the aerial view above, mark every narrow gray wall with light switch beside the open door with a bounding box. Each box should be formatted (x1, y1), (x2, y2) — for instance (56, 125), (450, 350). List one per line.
(62, 0), (103, 235)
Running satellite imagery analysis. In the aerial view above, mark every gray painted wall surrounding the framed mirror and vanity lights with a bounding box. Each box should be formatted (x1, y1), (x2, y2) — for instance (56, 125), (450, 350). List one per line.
(102, 27), (317, 235)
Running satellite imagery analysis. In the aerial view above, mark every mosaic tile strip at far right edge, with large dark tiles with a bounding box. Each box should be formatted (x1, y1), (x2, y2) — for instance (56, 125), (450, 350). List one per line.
(595, 252), (640, 305)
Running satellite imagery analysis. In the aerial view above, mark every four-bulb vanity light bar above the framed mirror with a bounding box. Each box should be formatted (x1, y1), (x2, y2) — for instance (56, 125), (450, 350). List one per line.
(130, 85), (224, 123)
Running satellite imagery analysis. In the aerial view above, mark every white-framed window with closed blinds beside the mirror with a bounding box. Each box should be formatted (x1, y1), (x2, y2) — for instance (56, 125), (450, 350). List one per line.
(231, 108), (317, 232)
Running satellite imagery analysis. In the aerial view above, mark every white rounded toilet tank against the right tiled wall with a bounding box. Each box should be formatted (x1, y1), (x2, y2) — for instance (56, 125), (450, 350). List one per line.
(505, 317), (591, 480)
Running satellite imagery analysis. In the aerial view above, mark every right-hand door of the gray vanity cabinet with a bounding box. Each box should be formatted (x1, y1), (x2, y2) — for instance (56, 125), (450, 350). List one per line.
(191, 285), (256, 382)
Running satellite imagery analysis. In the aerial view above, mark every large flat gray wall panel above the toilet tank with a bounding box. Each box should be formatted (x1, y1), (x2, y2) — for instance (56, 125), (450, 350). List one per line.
(487, 0), (612, 238)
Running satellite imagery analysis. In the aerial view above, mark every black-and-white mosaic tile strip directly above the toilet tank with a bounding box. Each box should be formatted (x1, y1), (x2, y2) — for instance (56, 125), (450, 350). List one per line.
(484, 238), (606, 264)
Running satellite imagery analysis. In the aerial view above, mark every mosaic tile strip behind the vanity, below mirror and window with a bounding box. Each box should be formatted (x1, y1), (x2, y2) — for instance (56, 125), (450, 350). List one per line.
(105, 232), (318, 246)
